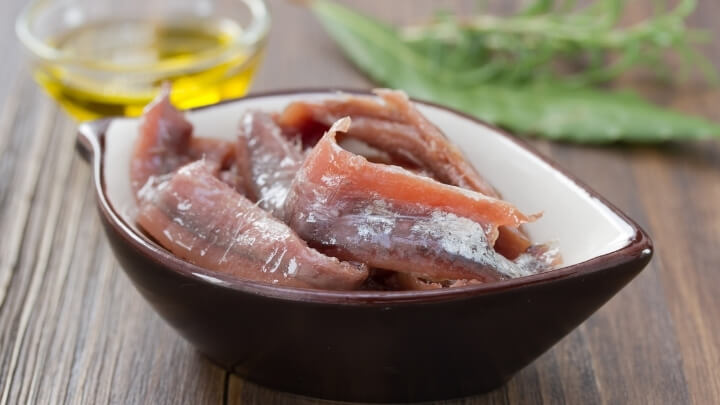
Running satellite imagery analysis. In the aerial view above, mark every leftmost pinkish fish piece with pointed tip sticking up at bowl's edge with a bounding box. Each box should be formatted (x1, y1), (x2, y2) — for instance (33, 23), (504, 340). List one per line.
(130, 88), (236, 195)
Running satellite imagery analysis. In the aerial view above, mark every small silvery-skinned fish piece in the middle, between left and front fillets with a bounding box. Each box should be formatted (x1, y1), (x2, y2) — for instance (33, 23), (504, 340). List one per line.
(237, 111), (305, 218)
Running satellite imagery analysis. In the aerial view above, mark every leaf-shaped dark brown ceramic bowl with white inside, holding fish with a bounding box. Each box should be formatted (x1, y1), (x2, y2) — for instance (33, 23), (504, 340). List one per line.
(79, 90), (652, 402)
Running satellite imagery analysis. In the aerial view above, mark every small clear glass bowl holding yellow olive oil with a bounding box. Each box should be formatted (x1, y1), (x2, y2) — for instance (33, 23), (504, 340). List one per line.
(16, 0), (270, 120)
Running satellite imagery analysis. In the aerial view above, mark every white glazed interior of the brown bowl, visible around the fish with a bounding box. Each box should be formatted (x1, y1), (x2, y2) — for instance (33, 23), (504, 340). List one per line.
(103, 93), (634, 266)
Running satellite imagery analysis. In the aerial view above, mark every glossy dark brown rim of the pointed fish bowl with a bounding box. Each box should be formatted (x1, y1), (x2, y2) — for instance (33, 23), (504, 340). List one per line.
(77, 87), (653, 305)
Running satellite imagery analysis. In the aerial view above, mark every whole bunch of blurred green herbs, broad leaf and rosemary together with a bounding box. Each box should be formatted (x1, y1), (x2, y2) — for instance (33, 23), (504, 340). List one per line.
(310, 0), (720, 143)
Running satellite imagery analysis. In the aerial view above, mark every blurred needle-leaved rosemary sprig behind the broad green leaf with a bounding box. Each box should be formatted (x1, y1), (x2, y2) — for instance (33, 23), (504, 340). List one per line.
(400, 0), (718, 86)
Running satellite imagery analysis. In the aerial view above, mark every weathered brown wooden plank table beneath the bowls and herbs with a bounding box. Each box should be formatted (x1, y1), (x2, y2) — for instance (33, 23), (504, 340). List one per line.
(0, 0), (720, 405)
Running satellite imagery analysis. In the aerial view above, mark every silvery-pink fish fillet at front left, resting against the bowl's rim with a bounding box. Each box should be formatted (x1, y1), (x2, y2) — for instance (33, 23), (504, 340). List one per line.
(137, 160), (368, 290)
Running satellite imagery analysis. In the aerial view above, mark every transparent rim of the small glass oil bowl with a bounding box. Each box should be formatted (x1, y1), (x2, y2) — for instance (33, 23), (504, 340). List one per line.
(15, 0), (270, 74)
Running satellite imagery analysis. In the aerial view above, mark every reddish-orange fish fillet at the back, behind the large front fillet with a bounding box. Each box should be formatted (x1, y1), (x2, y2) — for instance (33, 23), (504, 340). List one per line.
(277, 89), (530, 259)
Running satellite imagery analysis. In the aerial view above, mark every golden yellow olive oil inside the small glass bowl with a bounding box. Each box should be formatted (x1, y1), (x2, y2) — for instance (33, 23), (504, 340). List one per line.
(35, 18), (263, 121)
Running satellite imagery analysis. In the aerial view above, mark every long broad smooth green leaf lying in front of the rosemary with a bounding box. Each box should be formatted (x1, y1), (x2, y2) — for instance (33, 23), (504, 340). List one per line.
(310, 0), (720, 143)
